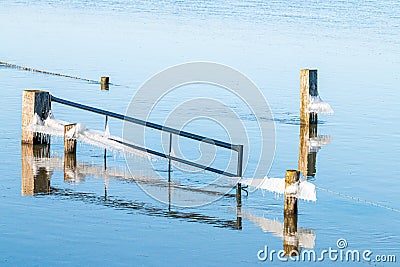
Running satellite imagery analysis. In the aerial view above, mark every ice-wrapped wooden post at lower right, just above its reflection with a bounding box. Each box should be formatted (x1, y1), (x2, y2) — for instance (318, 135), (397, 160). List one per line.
(284, 170), (300, 215)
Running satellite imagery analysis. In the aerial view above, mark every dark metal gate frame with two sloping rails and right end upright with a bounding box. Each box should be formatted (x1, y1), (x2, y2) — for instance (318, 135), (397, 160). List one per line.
(51, 95), (243, 177)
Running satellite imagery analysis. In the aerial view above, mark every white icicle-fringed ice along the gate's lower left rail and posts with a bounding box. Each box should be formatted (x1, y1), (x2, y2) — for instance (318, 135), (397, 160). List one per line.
(27, 111), (156, 161)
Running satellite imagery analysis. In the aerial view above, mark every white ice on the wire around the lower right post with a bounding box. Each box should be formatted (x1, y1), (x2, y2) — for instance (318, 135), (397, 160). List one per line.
(239, 176), (317, 201)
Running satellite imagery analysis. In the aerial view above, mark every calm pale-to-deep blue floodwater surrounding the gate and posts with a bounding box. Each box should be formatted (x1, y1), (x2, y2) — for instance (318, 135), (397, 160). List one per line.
(0, 0), (400, 266)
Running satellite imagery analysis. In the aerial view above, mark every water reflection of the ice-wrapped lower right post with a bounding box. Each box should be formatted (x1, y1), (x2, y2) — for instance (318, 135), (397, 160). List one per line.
(283, 214), (300, 257)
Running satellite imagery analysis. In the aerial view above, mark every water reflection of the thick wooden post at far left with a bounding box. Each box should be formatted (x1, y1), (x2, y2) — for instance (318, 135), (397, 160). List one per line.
(21, 144), (52, 196)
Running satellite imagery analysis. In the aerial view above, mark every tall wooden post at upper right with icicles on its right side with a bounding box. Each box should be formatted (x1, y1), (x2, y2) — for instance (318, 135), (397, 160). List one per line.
(300, 69), (318, 125)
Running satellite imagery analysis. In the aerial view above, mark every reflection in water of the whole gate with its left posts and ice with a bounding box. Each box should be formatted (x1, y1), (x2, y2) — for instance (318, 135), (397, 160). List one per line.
(21, 144), (242, 230)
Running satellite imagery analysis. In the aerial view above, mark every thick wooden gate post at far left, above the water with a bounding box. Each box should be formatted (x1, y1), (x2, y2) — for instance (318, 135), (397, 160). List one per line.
(21, 90), (51, 144)
